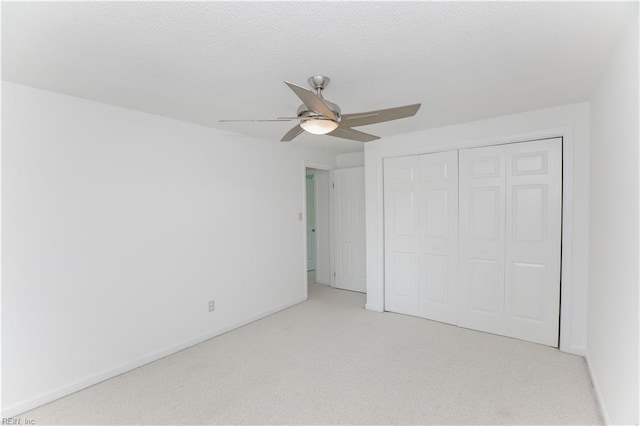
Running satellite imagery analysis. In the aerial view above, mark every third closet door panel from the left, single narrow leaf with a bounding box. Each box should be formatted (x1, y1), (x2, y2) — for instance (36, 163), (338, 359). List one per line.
(458, 145), (505, 334)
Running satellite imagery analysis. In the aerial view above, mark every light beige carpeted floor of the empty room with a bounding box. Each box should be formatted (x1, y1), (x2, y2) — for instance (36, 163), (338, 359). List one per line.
(21, 284), (602, 425)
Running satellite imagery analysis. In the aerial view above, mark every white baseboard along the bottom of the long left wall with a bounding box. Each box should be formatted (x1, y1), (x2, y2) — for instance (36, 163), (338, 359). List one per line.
(1, 297), (307, 418)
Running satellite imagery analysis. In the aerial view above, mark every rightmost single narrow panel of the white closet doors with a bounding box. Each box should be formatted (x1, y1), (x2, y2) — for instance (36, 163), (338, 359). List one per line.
(504, 139), (562, 346)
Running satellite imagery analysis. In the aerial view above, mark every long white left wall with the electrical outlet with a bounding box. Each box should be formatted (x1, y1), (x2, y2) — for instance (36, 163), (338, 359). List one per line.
(2, 83), (335, 417)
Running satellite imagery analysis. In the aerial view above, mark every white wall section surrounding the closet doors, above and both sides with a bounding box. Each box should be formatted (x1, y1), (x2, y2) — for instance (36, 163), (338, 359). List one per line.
(365, 103), (589, 355)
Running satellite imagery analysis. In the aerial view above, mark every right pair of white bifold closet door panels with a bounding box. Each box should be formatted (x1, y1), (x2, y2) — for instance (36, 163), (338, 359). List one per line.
(458, 139), (562, 347)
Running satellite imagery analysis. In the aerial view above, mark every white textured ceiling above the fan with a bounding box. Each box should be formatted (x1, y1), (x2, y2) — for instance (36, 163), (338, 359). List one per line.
(2, 2), (638, 153)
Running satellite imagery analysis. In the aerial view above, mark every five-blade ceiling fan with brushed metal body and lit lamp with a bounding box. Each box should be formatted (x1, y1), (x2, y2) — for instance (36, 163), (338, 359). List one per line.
(220, 75), (421, 142)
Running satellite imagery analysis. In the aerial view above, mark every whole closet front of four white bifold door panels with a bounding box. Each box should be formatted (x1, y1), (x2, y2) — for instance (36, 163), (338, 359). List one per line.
(384, 138), (562, 347)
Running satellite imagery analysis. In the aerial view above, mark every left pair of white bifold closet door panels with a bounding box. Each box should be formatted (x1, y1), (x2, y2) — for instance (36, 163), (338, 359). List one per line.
(384, 151), (458, 324)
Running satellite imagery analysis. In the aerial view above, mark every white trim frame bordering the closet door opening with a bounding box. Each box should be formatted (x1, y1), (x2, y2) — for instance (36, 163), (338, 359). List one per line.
(365, 127), (584, 355)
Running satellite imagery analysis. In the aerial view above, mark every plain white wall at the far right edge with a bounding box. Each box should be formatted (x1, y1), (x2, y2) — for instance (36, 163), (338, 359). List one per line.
(587, 17), (640, 424)
